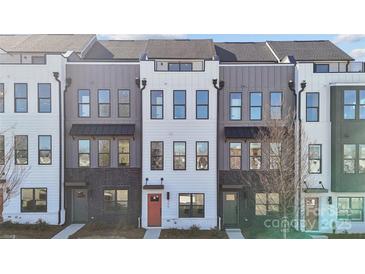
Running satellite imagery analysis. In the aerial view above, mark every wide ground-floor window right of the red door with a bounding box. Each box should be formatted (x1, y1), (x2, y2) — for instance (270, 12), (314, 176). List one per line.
(179, 193), (204, 218)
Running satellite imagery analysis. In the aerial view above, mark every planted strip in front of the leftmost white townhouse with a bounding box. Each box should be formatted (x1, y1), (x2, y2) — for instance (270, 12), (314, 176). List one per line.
(0, 222), (64, 239)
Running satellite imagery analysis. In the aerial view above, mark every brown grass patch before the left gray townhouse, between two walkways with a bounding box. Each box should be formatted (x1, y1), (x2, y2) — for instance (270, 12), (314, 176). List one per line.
(70, 222), (145, 239)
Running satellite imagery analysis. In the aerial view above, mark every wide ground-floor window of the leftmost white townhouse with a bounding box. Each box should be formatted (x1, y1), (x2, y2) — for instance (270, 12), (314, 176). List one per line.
(21, 188), (47, 212)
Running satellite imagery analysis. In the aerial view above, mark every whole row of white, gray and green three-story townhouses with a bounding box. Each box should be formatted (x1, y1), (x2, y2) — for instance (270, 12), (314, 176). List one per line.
(0, 35), (365, 231)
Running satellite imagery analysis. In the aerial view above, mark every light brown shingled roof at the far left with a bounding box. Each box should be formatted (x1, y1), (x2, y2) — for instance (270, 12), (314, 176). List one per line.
(0, 34), (95, 53)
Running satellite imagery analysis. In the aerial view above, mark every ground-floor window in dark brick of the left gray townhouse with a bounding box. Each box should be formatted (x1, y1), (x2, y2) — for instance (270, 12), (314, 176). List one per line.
(104, 189), (128, 213)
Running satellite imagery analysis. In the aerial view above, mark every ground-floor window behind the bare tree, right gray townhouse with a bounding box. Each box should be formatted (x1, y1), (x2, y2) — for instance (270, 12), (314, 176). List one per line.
(255, 193), (280, 216)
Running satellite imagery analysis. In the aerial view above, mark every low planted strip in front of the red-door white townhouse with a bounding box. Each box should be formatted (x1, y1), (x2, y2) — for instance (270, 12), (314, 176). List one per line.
(160, 229), (228, 239)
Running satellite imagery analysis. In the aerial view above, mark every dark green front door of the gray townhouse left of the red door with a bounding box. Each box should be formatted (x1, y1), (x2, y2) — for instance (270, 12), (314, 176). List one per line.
(72, 189), (88, 223)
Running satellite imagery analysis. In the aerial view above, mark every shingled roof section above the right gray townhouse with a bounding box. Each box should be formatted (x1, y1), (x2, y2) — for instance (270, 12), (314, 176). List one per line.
(215, 42), (277, 62)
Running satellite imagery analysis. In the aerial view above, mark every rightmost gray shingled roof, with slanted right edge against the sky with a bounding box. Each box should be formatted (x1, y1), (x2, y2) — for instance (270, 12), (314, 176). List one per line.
(267, 40), (353, 61)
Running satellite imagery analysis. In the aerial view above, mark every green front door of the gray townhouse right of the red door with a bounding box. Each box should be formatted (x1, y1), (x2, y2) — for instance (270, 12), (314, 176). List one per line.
(223, 192), (239, 227)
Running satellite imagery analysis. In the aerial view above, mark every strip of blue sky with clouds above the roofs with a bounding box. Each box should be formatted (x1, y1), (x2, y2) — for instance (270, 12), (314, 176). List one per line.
(98, 34), (365, 61)
